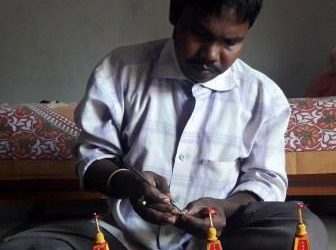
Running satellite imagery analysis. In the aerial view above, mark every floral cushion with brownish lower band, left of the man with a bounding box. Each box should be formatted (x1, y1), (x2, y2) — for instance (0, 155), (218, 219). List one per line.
(0, 103), (80, 180)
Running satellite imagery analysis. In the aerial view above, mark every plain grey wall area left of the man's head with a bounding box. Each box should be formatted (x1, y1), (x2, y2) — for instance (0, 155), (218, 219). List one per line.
(0, 0), (171, 103)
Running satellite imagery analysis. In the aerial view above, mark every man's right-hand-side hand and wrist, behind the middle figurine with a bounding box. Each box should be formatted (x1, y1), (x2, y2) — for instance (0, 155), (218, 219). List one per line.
(175, 192), (257, 238)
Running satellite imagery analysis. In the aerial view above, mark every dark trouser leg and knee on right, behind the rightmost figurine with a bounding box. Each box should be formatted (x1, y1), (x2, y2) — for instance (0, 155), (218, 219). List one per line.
(221, 202), (328, 250)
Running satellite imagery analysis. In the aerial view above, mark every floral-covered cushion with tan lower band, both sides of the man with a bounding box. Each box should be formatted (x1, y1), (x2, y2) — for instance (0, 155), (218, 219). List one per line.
(0, 97), (336, 184)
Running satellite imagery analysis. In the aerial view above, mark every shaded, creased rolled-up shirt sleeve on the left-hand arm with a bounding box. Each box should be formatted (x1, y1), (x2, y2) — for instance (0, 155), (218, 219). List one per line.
(75, 60), (123, 186)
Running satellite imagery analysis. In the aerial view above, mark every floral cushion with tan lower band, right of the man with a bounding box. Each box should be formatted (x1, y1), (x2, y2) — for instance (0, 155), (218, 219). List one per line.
(285, 97), (336, 174)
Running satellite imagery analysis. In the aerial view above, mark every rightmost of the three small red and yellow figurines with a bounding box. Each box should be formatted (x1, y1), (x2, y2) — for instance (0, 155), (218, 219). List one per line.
(294, 202), (310, 250)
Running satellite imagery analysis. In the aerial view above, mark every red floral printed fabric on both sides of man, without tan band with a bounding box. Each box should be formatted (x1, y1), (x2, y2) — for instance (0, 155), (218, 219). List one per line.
(0, 97), (336, 160)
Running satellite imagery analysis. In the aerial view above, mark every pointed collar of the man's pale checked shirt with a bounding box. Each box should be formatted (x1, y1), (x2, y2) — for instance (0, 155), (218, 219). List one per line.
(152, 38), (237, 91)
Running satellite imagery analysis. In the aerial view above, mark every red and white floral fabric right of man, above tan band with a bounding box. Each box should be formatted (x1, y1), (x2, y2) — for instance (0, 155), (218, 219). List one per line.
(285, 97), (336, 152)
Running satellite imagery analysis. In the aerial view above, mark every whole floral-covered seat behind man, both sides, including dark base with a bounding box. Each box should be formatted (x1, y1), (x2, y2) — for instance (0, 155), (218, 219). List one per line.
(0, 97), (336, 200)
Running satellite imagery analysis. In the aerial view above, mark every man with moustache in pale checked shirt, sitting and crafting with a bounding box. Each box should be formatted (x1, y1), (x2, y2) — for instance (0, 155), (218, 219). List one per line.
(0, 0), (327, 250)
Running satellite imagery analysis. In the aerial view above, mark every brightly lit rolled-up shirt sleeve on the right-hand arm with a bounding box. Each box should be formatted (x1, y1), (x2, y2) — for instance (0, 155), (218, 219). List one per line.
(232, 92), (290, 201)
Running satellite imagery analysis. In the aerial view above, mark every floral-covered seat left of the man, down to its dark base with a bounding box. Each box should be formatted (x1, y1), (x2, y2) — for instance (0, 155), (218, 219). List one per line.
(0, 103), (104, 201)
